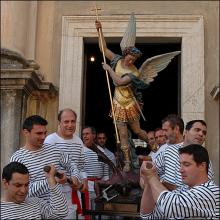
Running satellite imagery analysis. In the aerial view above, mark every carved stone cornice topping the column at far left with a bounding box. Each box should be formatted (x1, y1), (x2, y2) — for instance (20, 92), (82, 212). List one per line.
(0, 48), (58, 97)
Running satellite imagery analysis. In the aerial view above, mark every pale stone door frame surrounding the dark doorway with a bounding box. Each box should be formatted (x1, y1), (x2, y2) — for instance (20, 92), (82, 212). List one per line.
(59, 15), (205, 134)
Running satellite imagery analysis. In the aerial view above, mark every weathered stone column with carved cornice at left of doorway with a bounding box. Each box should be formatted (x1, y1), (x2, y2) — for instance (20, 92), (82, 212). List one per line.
(1, 49), (57, 168)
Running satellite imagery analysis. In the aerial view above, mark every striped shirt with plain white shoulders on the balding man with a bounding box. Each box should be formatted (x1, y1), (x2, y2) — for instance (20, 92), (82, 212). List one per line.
(44, 133), (87, 178)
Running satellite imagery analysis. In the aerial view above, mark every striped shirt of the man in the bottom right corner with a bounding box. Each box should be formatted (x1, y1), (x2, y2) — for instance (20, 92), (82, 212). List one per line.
(140, 181), (220, 219)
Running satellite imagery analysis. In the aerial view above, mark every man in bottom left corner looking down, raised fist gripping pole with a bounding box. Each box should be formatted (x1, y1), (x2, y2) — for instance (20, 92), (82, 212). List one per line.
(1, 162), (68, 219)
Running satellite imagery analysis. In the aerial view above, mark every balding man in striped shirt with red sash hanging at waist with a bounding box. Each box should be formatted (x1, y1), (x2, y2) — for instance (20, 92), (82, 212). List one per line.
(44, 108), (88, 218)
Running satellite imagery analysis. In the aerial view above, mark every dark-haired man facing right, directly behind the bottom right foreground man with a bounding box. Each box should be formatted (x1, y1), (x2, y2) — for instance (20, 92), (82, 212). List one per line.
(155, 120), (214, 190)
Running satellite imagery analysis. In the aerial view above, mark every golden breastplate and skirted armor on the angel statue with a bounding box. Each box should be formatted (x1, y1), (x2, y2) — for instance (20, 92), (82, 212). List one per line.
(113, 60), (140, 122)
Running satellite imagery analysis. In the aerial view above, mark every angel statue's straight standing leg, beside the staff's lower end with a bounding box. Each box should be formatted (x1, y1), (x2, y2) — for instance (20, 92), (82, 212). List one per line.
(117, 123), (131, 172)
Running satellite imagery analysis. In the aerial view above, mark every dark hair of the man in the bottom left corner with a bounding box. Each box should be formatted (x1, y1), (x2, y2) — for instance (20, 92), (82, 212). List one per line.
(2, 162), (29, 182)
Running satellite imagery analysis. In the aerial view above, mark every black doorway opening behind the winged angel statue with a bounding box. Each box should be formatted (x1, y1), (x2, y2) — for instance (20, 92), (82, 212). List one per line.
(83, 42), (181, 151)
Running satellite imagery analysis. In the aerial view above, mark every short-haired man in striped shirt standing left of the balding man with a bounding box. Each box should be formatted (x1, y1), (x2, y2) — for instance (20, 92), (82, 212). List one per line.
(11, 115), (80, 219)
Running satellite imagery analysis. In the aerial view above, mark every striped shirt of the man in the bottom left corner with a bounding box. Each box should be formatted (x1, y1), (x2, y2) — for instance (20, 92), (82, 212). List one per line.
(1, 184), (68, 219)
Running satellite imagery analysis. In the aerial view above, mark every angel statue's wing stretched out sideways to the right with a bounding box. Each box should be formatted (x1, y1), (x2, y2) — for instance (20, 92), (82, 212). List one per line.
(139, 51), (181, 84)
